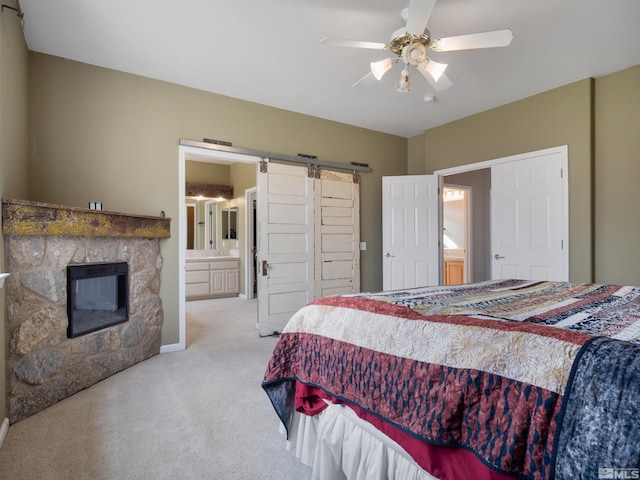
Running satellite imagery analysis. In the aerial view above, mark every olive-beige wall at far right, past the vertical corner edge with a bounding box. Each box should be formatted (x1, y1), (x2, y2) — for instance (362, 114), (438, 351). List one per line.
(594, 65), (640, 285)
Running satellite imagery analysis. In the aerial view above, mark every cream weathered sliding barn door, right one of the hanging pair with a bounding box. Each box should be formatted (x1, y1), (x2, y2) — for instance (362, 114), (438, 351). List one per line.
(315, 170), (360, 297)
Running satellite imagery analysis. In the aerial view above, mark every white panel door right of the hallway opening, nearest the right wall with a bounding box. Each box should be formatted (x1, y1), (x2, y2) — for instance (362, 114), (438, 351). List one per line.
(491, 152), (569, 281)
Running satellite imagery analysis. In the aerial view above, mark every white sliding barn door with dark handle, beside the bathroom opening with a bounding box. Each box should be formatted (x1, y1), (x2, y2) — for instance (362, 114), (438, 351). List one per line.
(257, 161), (314, 335)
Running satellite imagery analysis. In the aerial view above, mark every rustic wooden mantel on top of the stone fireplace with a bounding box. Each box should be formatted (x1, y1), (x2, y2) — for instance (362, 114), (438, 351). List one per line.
(2, 199), (171, 238)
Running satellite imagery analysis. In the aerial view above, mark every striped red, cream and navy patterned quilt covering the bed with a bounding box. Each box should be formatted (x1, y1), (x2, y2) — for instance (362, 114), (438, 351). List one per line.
(263, 281), (640, 480)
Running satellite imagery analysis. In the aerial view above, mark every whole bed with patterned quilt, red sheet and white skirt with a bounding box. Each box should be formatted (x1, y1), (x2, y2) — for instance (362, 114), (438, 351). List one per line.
(262, 280), (640, 480)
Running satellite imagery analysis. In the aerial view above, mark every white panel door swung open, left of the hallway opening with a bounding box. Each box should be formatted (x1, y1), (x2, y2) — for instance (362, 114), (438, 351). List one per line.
(382, 175), (440, 290)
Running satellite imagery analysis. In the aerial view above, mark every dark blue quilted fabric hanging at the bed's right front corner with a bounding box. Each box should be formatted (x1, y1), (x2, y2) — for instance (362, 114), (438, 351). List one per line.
(555, 337), (640, 480)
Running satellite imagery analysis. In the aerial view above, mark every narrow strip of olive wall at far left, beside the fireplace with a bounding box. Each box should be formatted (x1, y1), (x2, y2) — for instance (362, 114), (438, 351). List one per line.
(0, 4), (28, 423)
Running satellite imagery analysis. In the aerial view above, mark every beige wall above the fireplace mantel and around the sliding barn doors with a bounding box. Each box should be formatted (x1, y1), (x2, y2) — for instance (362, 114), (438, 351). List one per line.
(29, 53), (407, 344)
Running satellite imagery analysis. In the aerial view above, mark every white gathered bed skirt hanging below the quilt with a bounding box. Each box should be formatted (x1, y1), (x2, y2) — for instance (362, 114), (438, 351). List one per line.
(282, 404), (438, 480)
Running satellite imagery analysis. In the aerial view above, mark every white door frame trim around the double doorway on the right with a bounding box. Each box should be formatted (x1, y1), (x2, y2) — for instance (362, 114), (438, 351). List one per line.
(433, 145), (569, 281)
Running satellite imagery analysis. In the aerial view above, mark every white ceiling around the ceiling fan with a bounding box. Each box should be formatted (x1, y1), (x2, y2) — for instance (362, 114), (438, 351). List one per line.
(16, 0), (640, 137)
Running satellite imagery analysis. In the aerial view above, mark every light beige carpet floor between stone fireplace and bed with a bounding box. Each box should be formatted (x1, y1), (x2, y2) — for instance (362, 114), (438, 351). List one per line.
(0, 298), (311, 480)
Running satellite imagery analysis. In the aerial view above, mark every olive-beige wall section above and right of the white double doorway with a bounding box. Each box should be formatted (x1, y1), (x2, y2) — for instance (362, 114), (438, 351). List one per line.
(423, 79), (593, 282)
